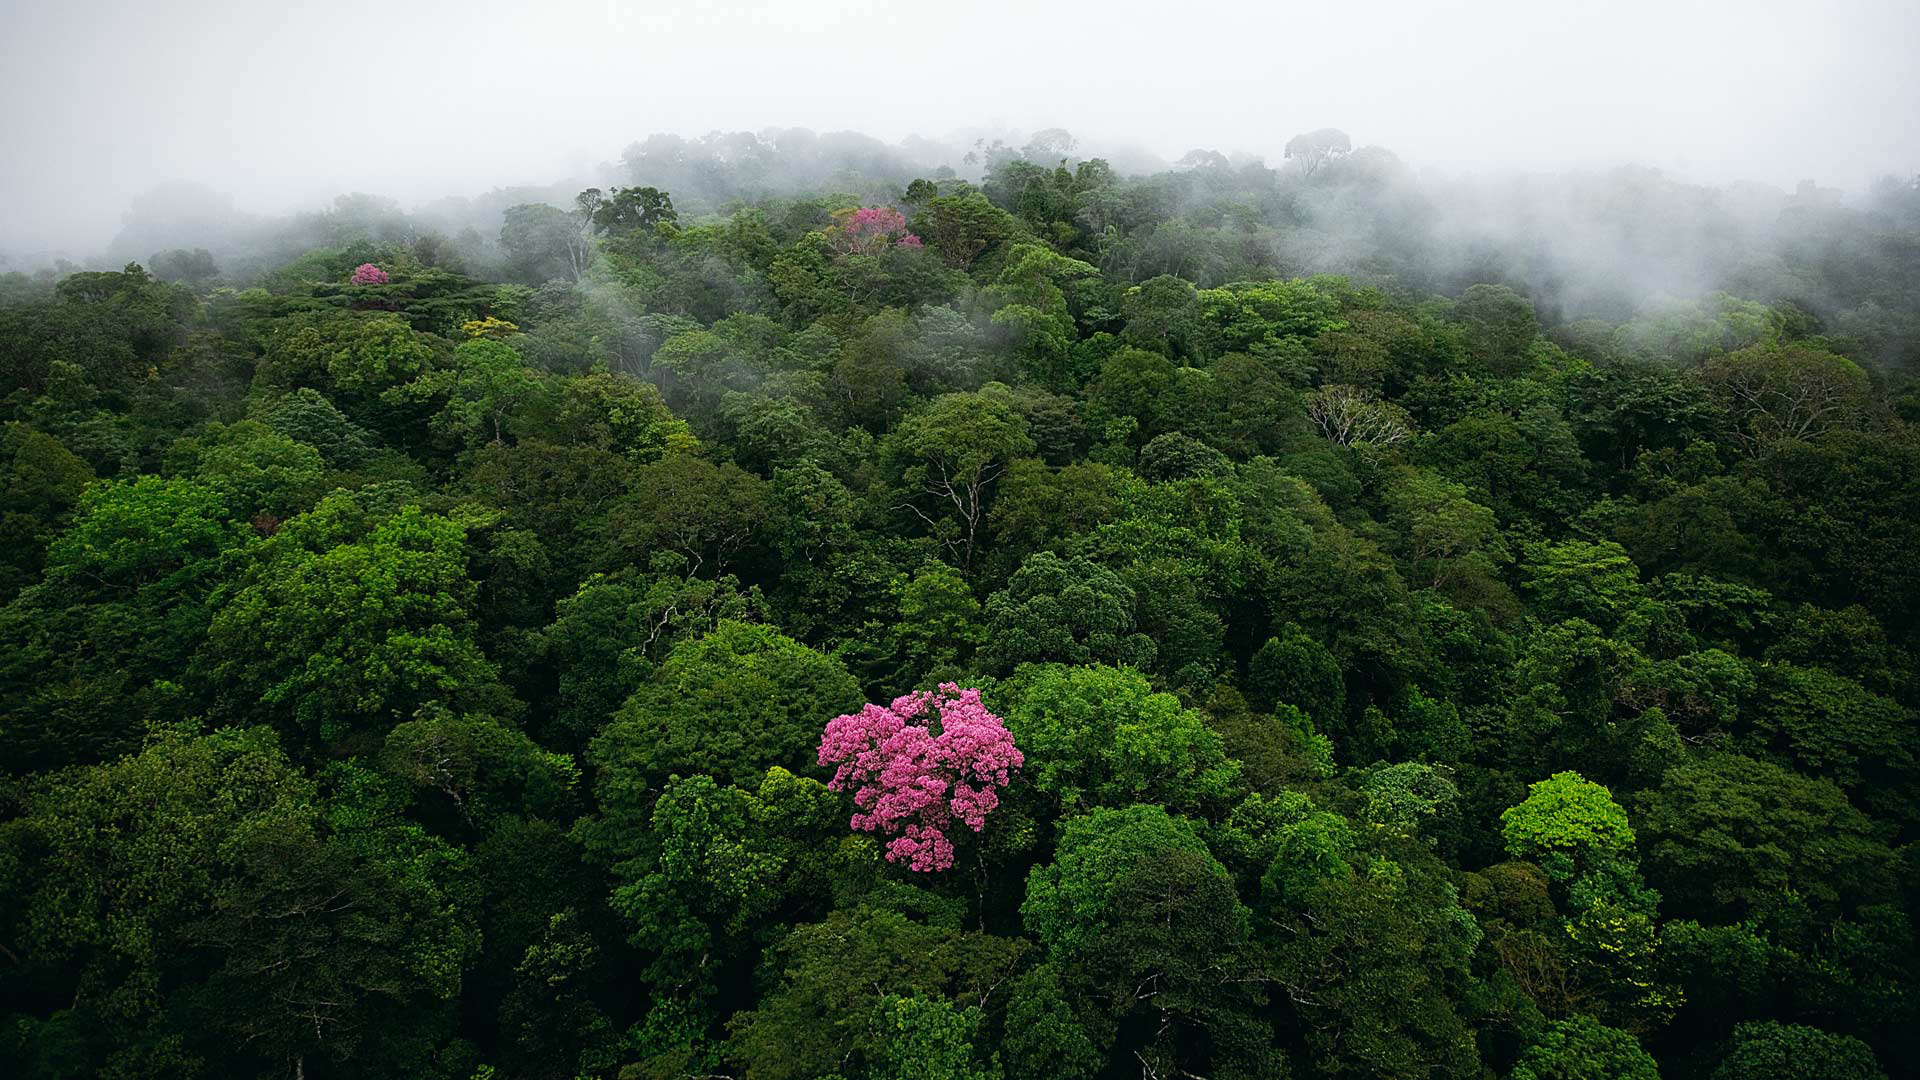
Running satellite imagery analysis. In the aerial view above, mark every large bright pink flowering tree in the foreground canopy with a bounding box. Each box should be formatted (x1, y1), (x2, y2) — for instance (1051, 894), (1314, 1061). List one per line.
(820, 682), (1025, 872)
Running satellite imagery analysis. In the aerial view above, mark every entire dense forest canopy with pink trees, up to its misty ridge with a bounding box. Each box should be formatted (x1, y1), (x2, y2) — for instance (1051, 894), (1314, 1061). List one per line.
(0, 129), (1920, 1080)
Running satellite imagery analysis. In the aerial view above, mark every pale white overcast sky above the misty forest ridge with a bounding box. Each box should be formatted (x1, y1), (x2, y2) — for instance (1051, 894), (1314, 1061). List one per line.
(0, 0), (1920, 254)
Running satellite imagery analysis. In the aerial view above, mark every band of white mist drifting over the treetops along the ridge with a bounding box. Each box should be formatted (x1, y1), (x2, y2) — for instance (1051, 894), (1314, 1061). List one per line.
(8, 129), (1920, 363)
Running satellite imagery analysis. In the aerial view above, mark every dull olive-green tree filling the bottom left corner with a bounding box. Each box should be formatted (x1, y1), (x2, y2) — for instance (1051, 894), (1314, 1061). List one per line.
(0, 730), (313, 1074)
